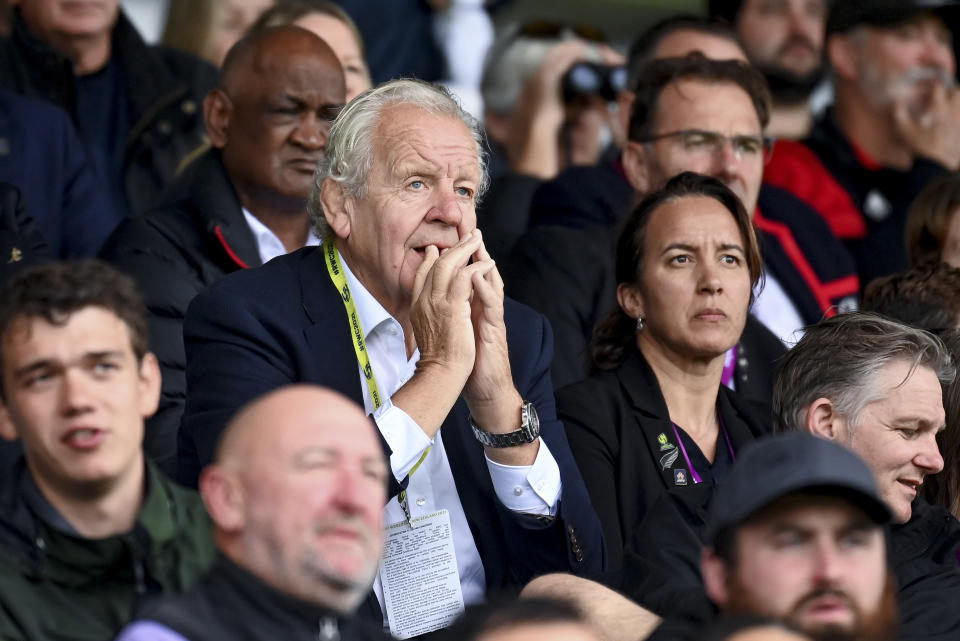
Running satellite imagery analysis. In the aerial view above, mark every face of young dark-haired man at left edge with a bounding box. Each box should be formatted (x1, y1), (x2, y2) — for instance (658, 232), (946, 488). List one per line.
(2, 307), (160, 493)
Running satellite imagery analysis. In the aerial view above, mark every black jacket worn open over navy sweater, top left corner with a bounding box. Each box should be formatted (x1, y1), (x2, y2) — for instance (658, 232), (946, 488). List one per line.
(0, 11), (217, 214)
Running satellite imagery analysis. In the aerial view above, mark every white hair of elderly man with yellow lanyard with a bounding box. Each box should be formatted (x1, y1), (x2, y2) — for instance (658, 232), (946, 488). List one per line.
(307, 78), (490, 238)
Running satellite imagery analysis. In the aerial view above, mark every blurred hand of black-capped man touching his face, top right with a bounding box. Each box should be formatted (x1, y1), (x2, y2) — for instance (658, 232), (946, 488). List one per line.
(893, 84), (960, 170)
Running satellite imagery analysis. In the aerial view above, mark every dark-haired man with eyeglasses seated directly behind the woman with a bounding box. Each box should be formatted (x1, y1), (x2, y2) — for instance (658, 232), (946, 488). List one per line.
(507, 54), (859, 392)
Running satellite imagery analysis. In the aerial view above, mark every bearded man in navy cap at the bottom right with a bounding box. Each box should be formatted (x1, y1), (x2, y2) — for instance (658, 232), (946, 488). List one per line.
(692, 434), (896, 641)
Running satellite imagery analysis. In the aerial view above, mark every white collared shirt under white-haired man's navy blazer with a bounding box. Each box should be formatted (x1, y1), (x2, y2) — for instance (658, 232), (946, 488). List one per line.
(341, 256), (562, 625)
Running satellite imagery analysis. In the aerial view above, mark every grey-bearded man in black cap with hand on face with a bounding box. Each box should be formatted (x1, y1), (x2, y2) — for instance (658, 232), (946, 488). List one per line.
(767, 0), (960, 285)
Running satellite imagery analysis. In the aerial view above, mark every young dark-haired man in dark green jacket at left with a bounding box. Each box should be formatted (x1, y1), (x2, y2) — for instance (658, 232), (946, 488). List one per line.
(0, 261), (213, 641)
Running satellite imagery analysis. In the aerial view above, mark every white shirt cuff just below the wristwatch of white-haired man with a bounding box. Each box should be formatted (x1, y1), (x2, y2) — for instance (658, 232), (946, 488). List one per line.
(485, 439), (563, 516)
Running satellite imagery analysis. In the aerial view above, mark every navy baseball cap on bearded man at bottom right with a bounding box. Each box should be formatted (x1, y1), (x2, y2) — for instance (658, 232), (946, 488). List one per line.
(705, 432), (890, 544)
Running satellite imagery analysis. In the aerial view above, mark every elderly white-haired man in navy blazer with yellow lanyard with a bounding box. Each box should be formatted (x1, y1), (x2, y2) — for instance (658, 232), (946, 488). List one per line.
(179, 80), (603, 638)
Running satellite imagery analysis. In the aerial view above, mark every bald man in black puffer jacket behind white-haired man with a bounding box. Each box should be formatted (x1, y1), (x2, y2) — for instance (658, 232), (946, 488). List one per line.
(101, 26), (346, 474)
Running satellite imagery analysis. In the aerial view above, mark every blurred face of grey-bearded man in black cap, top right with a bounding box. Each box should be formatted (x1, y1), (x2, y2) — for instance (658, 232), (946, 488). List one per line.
(846, 14), (956, 116)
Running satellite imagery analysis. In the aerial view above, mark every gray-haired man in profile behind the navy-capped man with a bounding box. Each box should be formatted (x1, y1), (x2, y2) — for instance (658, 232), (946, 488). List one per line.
(773, 314), (960, 640)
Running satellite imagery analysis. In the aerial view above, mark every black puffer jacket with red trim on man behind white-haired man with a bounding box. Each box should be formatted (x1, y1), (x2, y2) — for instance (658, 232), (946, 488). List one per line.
(100, 151), (260, 474)
